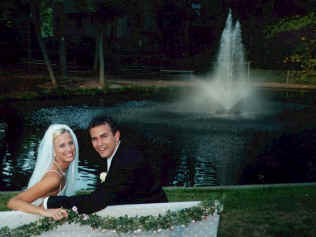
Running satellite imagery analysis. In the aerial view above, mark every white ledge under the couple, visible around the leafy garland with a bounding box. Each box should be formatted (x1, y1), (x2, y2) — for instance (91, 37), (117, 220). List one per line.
(0, 201), (220, 237)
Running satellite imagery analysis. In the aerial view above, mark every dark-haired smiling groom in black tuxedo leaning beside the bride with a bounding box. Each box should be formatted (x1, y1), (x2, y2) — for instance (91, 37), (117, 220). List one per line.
(44, 117), (167, 214)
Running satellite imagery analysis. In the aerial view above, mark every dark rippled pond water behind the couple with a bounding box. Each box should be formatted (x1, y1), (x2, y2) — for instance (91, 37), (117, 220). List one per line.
(0, 90), (316, 190)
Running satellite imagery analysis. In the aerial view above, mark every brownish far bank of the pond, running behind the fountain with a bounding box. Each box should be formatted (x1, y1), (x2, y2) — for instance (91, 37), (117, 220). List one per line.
(0, 74), (316, 102)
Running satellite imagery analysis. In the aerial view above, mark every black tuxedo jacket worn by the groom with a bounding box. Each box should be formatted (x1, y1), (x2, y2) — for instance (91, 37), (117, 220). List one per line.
(47, 142), (167, 214)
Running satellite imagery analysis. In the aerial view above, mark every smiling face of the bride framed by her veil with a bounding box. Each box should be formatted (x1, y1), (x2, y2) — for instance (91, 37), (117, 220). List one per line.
(54, 132), (76, 163)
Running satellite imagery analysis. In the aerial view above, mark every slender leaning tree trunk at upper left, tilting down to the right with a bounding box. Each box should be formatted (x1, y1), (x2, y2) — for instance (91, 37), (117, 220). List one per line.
(30, 1), (57, 88)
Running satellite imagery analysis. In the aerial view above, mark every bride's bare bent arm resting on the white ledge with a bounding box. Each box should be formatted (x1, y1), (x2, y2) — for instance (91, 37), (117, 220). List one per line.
(7, 173), (68, 220)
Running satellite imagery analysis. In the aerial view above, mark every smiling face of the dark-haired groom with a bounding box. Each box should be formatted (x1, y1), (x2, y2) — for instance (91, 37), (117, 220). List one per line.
(90, 124), (120, 158)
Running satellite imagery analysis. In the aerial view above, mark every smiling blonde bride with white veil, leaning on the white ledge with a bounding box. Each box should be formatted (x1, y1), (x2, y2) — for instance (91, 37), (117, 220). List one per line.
(7, 124), (79, 220)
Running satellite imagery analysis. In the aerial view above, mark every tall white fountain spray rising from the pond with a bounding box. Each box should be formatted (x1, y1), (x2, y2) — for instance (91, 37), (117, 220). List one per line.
(196, 11), (251, 114)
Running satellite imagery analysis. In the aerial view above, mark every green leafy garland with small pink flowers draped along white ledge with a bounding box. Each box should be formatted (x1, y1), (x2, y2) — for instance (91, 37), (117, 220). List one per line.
(0, 200), (223, 237)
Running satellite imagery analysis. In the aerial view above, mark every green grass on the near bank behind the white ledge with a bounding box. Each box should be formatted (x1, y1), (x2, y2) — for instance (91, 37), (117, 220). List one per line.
(0, 185), (316, 237)
